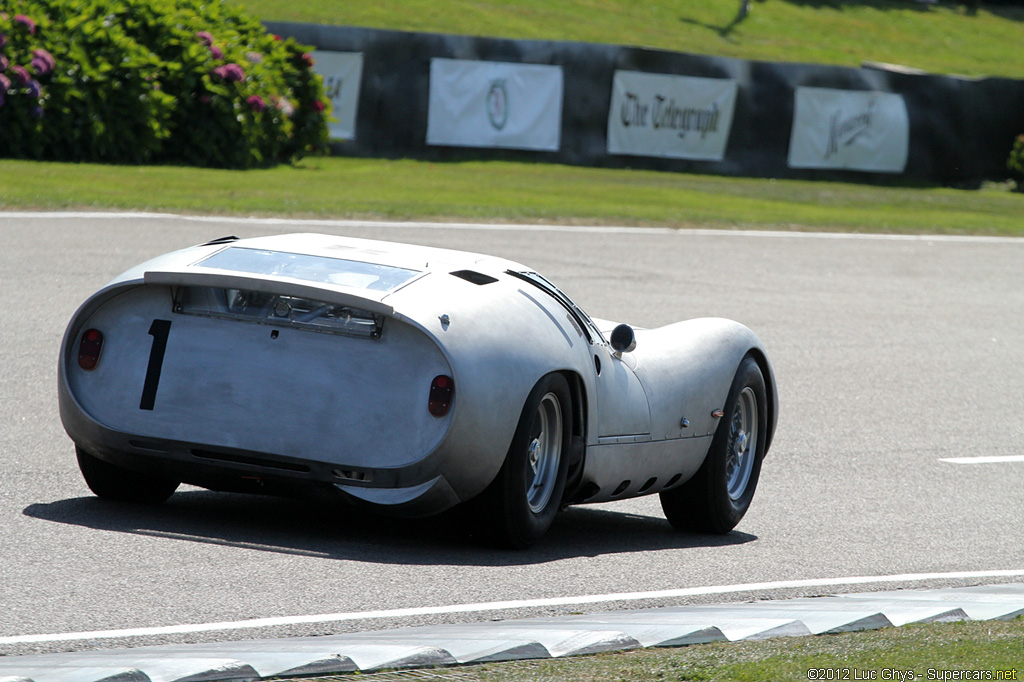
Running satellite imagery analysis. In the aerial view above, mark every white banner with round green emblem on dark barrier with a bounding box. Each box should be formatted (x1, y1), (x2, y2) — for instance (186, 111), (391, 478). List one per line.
(427, 58), (562, 152)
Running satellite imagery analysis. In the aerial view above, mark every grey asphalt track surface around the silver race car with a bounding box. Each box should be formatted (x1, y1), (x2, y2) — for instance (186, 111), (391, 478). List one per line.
(0, 213), (1024, 654)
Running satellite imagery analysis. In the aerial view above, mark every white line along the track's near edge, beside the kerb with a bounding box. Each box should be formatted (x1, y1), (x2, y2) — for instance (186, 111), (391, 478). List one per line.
(0, 569), (1024, 644)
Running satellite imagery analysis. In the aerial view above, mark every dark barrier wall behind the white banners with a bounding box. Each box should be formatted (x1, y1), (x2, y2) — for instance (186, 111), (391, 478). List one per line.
(266, 23), (1024, 186)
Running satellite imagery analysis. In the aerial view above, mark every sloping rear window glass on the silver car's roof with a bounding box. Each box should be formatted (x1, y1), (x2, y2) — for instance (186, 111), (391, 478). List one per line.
(196, 247), (420, 291)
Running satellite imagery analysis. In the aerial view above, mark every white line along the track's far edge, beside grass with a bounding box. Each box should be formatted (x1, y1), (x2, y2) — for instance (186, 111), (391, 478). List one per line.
(6, 211), (1024, 246)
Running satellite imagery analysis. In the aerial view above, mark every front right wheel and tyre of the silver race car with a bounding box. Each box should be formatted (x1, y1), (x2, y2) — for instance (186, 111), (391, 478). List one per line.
(660, 356), (768, 534)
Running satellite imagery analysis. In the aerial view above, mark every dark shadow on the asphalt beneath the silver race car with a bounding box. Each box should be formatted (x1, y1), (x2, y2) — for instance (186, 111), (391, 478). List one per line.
(24, 491), (757, 566)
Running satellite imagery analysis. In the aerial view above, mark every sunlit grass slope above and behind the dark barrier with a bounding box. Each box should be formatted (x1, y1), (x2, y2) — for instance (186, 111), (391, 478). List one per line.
(231, 0), (1024, 78)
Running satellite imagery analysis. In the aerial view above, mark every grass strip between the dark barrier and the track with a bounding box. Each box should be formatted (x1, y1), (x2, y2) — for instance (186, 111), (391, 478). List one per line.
(0, 158), (1024, 236)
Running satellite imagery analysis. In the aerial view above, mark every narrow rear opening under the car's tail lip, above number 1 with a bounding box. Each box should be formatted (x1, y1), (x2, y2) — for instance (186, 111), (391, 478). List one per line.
(174, 287), (384, 339)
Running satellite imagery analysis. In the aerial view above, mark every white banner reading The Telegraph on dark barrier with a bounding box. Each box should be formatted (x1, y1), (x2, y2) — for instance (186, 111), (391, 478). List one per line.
(608, 71), (737, 161)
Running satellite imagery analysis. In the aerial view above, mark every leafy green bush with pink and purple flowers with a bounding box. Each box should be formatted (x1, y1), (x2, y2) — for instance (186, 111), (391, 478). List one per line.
(0, 0), (329, 168)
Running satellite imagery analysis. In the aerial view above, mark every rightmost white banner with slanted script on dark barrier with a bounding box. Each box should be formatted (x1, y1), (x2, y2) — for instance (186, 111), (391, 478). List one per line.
(790, 87), (910, 173)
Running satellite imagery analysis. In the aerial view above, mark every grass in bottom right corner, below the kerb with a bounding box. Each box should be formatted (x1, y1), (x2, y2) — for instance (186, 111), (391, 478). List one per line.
(282, 619), (1024, 682)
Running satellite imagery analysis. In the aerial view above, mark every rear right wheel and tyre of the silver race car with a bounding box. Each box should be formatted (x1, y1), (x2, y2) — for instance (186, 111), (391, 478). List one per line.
(478, 374), (572, 549)
